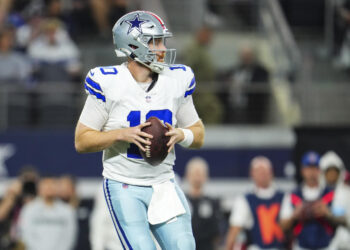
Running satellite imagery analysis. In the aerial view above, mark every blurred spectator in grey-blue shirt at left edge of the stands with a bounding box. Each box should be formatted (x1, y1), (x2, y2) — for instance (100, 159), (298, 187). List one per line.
(0, 26), (32, 84)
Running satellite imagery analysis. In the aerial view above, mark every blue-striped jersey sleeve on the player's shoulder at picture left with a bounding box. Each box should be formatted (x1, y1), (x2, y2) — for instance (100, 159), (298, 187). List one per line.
(84, 68), (106, 104)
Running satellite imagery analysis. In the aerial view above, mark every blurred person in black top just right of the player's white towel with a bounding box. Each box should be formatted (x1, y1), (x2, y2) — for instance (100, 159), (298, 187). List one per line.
(186, 157), (222, 250)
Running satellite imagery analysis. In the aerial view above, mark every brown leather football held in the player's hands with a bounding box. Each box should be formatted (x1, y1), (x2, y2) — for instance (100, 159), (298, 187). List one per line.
(140, 116), (170, 166)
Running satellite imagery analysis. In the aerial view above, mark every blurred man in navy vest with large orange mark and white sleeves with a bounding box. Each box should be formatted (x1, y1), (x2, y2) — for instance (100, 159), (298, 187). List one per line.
(226, 156), (284, 250)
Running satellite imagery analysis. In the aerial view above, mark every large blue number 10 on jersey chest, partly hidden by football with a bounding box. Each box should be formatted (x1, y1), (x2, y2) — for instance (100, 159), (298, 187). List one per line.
(127, 109), (173, 159)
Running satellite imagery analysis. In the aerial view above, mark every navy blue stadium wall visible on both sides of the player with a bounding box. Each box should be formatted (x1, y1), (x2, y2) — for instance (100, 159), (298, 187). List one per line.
(0, 131), (292, 178)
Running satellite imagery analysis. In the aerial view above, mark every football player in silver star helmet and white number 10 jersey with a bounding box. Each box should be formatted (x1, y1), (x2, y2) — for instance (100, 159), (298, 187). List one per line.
(75, 11), (204, 250)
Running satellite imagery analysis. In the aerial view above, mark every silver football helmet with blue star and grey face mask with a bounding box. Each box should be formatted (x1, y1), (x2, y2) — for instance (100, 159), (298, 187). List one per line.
(112, 11), (176, 73)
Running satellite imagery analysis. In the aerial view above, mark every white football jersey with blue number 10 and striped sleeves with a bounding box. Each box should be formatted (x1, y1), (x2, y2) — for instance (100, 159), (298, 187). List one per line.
(80, 63), (199, 186)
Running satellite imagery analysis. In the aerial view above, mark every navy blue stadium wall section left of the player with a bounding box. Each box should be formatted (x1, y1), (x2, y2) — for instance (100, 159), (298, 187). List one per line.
(0, 130), (102, 177)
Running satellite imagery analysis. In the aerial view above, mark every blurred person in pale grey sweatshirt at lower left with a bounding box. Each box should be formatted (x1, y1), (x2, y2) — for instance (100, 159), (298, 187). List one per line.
(19, 176), (77, 250)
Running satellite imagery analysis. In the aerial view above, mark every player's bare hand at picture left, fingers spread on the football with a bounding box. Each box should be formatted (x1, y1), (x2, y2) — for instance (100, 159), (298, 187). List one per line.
(122, 122), (153, 152)
